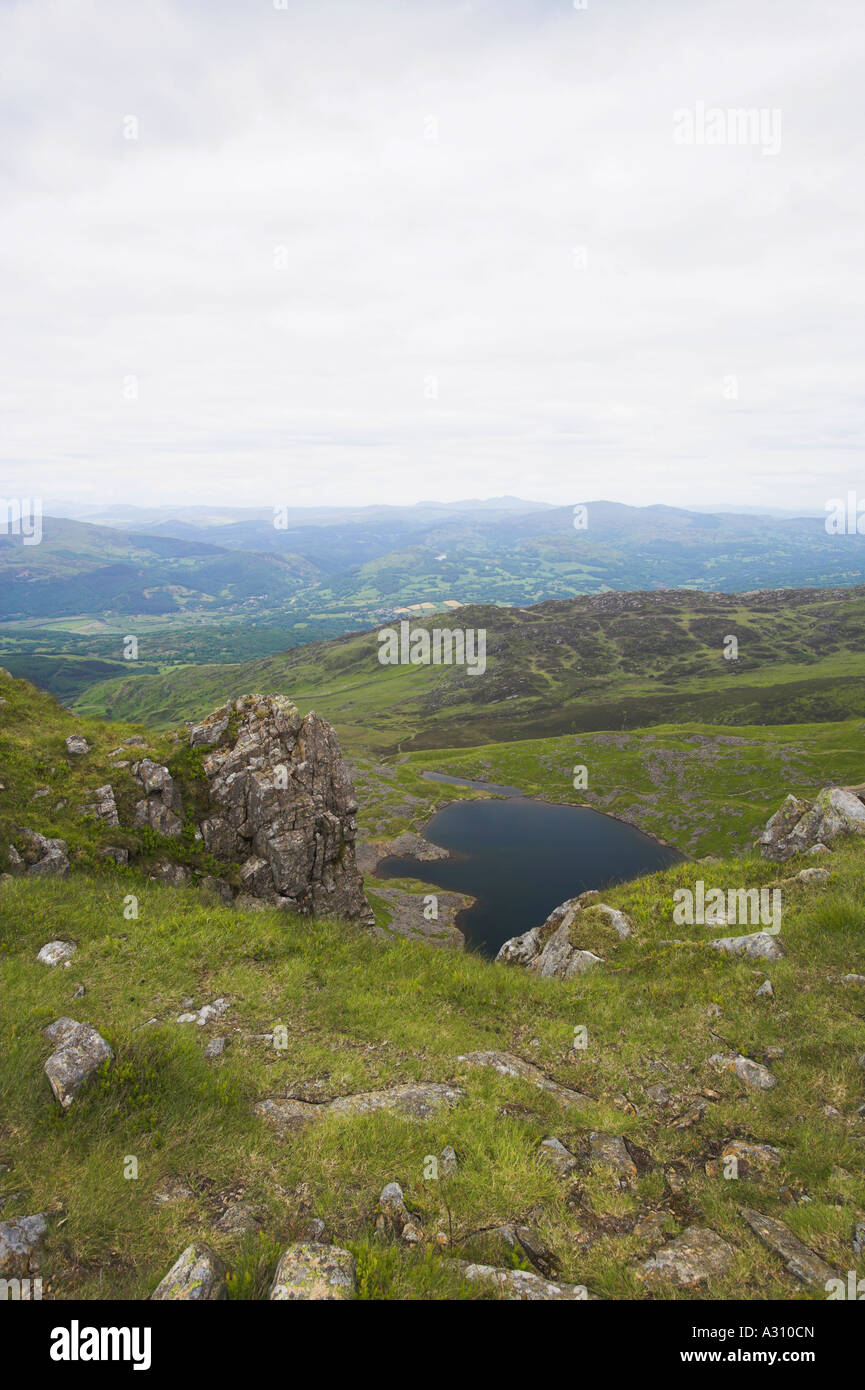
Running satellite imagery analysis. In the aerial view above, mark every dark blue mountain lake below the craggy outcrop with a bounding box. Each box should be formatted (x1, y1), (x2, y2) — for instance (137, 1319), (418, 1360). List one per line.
(375, 800), (681, 956)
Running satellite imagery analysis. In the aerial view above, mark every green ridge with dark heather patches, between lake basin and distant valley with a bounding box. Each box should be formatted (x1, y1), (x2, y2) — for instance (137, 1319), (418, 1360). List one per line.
(76, 588), (865, 751)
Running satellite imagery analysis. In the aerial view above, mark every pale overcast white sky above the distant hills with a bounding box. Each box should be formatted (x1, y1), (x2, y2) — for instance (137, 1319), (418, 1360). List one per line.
(0, 0), (865, 510)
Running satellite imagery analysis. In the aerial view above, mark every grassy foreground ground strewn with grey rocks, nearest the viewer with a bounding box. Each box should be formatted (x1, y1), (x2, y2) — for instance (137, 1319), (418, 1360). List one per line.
(0, 842), (865, 1300)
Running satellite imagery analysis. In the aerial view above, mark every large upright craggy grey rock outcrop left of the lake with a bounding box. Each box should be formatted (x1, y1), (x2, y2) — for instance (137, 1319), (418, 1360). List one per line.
(196, 695), (373, 922)
